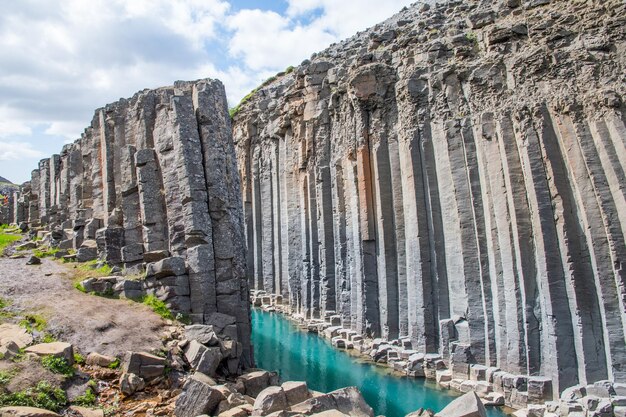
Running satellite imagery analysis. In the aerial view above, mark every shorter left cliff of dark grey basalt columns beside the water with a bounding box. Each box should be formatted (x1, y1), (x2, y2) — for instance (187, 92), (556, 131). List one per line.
(13, 80), (252, 366)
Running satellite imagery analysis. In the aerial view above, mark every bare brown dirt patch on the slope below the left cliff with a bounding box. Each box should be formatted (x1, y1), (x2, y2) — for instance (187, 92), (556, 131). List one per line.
(0, 257), (166, 355)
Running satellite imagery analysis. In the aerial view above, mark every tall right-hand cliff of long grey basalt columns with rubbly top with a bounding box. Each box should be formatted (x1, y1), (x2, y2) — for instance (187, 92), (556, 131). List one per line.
(233, 0), (626, 396)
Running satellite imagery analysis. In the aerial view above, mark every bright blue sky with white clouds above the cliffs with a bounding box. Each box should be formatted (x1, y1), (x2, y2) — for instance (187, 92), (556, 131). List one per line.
(0, 0), (414, 183)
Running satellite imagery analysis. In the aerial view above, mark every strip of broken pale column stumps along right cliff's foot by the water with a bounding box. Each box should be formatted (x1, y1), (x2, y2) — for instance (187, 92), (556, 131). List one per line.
(251, 291), (626, 417)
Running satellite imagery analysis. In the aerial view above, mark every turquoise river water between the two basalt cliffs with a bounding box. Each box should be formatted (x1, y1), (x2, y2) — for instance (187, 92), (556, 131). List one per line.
(252, 308), (506, 417)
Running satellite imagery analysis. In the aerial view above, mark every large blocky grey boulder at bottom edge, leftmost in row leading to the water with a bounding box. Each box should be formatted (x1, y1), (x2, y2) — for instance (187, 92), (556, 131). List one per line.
(174, 372), (225, 417)
